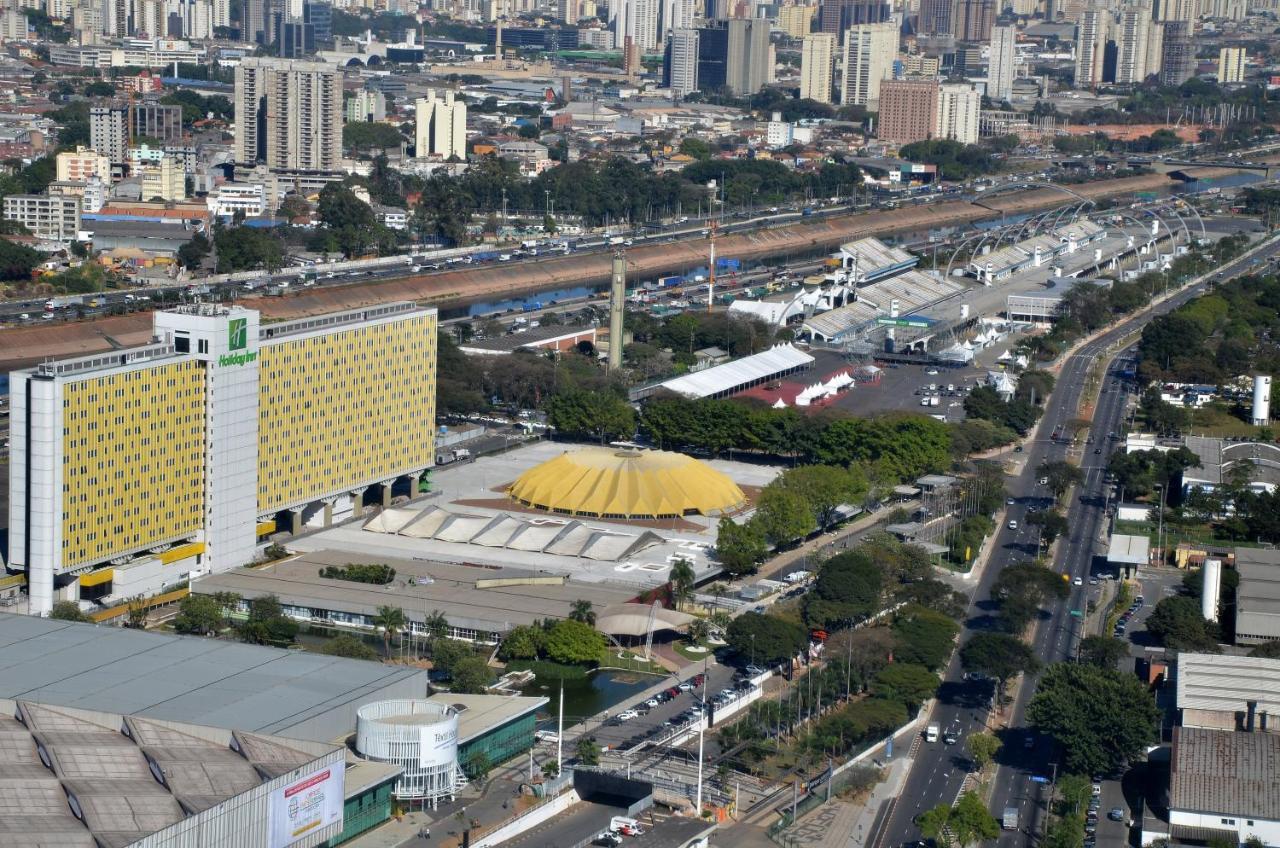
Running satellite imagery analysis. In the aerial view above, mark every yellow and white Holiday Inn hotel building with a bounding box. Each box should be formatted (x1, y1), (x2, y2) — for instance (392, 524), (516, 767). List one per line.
(9, 304), (436, 615)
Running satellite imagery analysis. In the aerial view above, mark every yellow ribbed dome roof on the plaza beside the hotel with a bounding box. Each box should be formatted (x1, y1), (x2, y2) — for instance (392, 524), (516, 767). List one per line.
(509, 447), (746, 519)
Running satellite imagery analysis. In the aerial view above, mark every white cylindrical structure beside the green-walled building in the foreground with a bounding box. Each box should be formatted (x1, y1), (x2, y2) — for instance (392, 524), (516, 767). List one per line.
(356, 699), (466, 807)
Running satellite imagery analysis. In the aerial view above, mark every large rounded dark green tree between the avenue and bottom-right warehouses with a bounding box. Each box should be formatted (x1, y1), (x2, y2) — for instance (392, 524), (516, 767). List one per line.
(1027, 662), (1160, 775)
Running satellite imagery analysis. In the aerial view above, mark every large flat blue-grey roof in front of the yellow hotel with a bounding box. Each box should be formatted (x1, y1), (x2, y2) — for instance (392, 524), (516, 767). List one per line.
(0, 614), (426, 738)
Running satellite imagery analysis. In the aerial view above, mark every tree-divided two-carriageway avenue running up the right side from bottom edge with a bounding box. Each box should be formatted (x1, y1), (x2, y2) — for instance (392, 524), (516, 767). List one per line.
(872, 233), (1280, 848)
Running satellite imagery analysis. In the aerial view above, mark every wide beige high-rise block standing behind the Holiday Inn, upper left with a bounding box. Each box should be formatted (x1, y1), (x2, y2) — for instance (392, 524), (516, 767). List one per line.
(236, 58), (342, 173)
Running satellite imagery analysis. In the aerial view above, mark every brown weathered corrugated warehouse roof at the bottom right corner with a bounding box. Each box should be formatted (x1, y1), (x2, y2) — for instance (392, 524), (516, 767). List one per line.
(1169, 728), (1280, 821)
